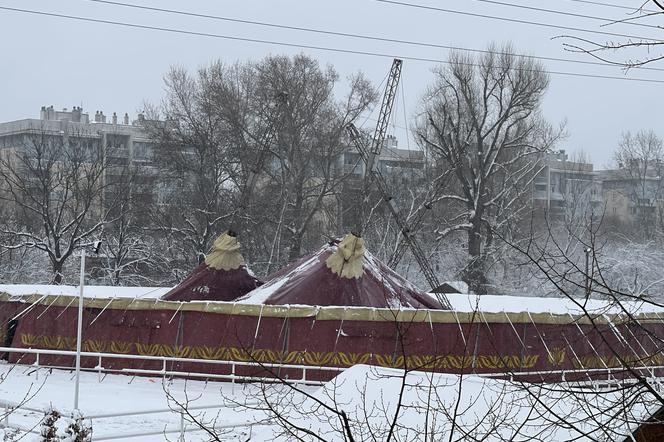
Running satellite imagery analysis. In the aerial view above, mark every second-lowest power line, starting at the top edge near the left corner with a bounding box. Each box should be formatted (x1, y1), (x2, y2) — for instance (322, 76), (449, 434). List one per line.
(74, 0), (664, 71)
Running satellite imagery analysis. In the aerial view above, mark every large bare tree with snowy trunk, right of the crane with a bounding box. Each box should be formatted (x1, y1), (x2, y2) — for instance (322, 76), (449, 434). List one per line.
(416, 46), (561, 293)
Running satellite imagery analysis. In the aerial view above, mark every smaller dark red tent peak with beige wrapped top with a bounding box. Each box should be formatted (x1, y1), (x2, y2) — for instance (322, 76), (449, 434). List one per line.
(162, 232), (262, 301)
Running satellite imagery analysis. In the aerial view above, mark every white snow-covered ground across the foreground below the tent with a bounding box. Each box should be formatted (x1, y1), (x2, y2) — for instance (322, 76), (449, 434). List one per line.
(0, 364), (656, 442)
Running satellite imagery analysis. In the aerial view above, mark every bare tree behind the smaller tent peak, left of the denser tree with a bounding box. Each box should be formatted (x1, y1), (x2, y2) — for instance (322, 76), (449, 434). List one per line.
(145, 64), (241, 263)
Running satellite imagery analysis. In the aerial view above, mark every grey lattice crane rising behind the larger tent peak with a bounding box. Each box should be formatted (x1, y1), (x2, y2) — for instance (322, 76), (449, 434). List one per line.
(346, 58), (452, 310)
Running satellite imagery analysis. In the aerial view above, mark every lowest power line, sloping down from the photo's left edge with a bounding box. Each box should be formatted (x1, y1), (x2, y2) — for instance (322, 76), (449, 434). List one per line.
(0, 6), (664, 83)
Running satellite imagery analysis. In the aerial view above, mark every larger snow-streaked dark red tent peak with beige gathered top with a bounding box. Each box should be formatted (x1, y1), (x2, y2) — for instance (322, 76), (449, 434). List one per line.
(238, 234), (441, 309)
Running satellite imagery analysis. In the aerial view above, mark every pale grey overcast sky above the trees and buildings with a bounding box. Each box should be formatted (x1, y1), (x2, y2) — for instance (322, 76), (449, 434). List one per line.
(0, 0), (664, 168)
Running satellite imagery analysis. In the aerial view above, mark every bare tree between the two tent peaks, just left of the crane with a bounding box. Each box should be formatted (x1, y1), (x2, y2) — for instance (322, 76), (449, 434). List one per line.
(228, 55), (376, 262)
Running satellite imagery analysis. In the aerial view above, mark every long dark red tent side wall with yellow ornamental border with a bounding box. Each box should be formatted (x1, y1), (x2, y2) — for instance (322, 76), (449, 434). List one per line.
(2, 298), (664, 380)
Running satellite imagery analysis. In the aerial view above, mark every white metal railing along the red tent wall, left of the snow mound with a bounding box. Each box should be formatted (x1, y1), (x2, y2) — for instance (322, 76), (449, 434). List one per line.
(0, 347), (345, 385)
